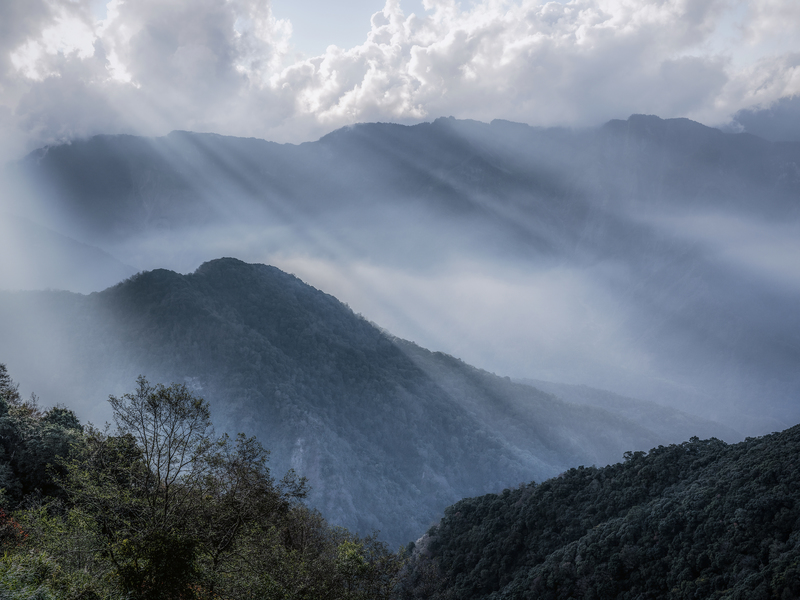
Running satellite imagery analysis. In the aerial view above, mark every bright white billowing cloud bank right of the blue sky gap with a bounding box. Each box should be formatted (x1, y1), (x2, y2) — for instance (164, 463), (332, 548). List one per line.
(276, 0), (727, 124)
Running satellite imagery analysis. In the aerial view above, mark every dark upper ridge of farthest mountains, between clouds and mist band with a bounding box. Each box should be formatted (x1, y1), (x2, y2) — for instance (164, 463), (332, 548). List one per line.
(5, 115), (800, 246)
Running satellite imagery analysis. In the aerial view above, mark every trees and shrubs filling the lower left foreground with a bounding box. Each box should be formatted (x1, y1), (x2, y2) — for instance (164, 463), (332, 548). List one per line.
(0, 365), (402, 600)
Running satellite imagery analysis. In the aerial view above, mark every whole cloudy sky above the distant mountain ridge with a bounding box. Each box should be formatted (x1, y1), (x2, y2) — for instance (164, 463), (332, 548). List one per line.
(0, 0), (800, 160)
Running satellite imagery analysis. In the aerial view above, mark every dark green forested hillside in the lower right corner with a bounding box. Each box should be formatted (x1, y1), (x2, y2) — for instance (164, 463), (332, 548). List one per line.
(405, 426), (800, 600)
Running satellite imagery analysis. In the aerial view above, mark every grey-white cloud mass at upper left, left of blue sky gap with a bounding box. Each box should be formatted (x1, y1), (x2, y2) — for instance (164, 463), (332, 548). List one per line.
(0, 0), (291, 155)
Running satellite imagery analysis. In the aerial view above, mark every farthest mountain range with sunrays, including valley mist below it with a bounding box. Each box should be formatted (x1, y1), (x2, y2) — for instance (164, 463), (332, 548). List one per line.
(4, 115), (800, 435)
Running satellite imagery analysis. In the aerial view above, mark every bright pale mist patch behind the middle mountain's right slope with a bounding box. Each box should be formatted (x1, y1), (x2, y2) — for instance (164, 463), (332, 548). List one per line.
(269, 255), (650, 383)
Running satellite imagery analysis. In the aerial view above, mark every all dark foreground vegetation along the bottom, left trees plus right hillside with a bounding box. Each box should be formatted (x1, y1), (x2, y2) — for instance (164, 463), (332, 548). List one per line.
(0, 365), (800, 600)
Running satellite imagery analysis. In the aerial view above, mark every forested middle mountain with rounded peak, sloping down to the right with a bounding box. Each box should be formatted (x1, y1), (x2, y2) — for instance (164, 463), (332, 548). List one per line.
(0, 258), (726, 544)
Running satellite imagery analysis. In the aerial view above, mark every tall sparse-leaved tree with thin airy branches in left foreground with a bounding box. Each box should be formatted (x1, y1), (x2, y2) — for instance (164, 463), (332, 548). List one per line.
(67, 377), (214, 600)
